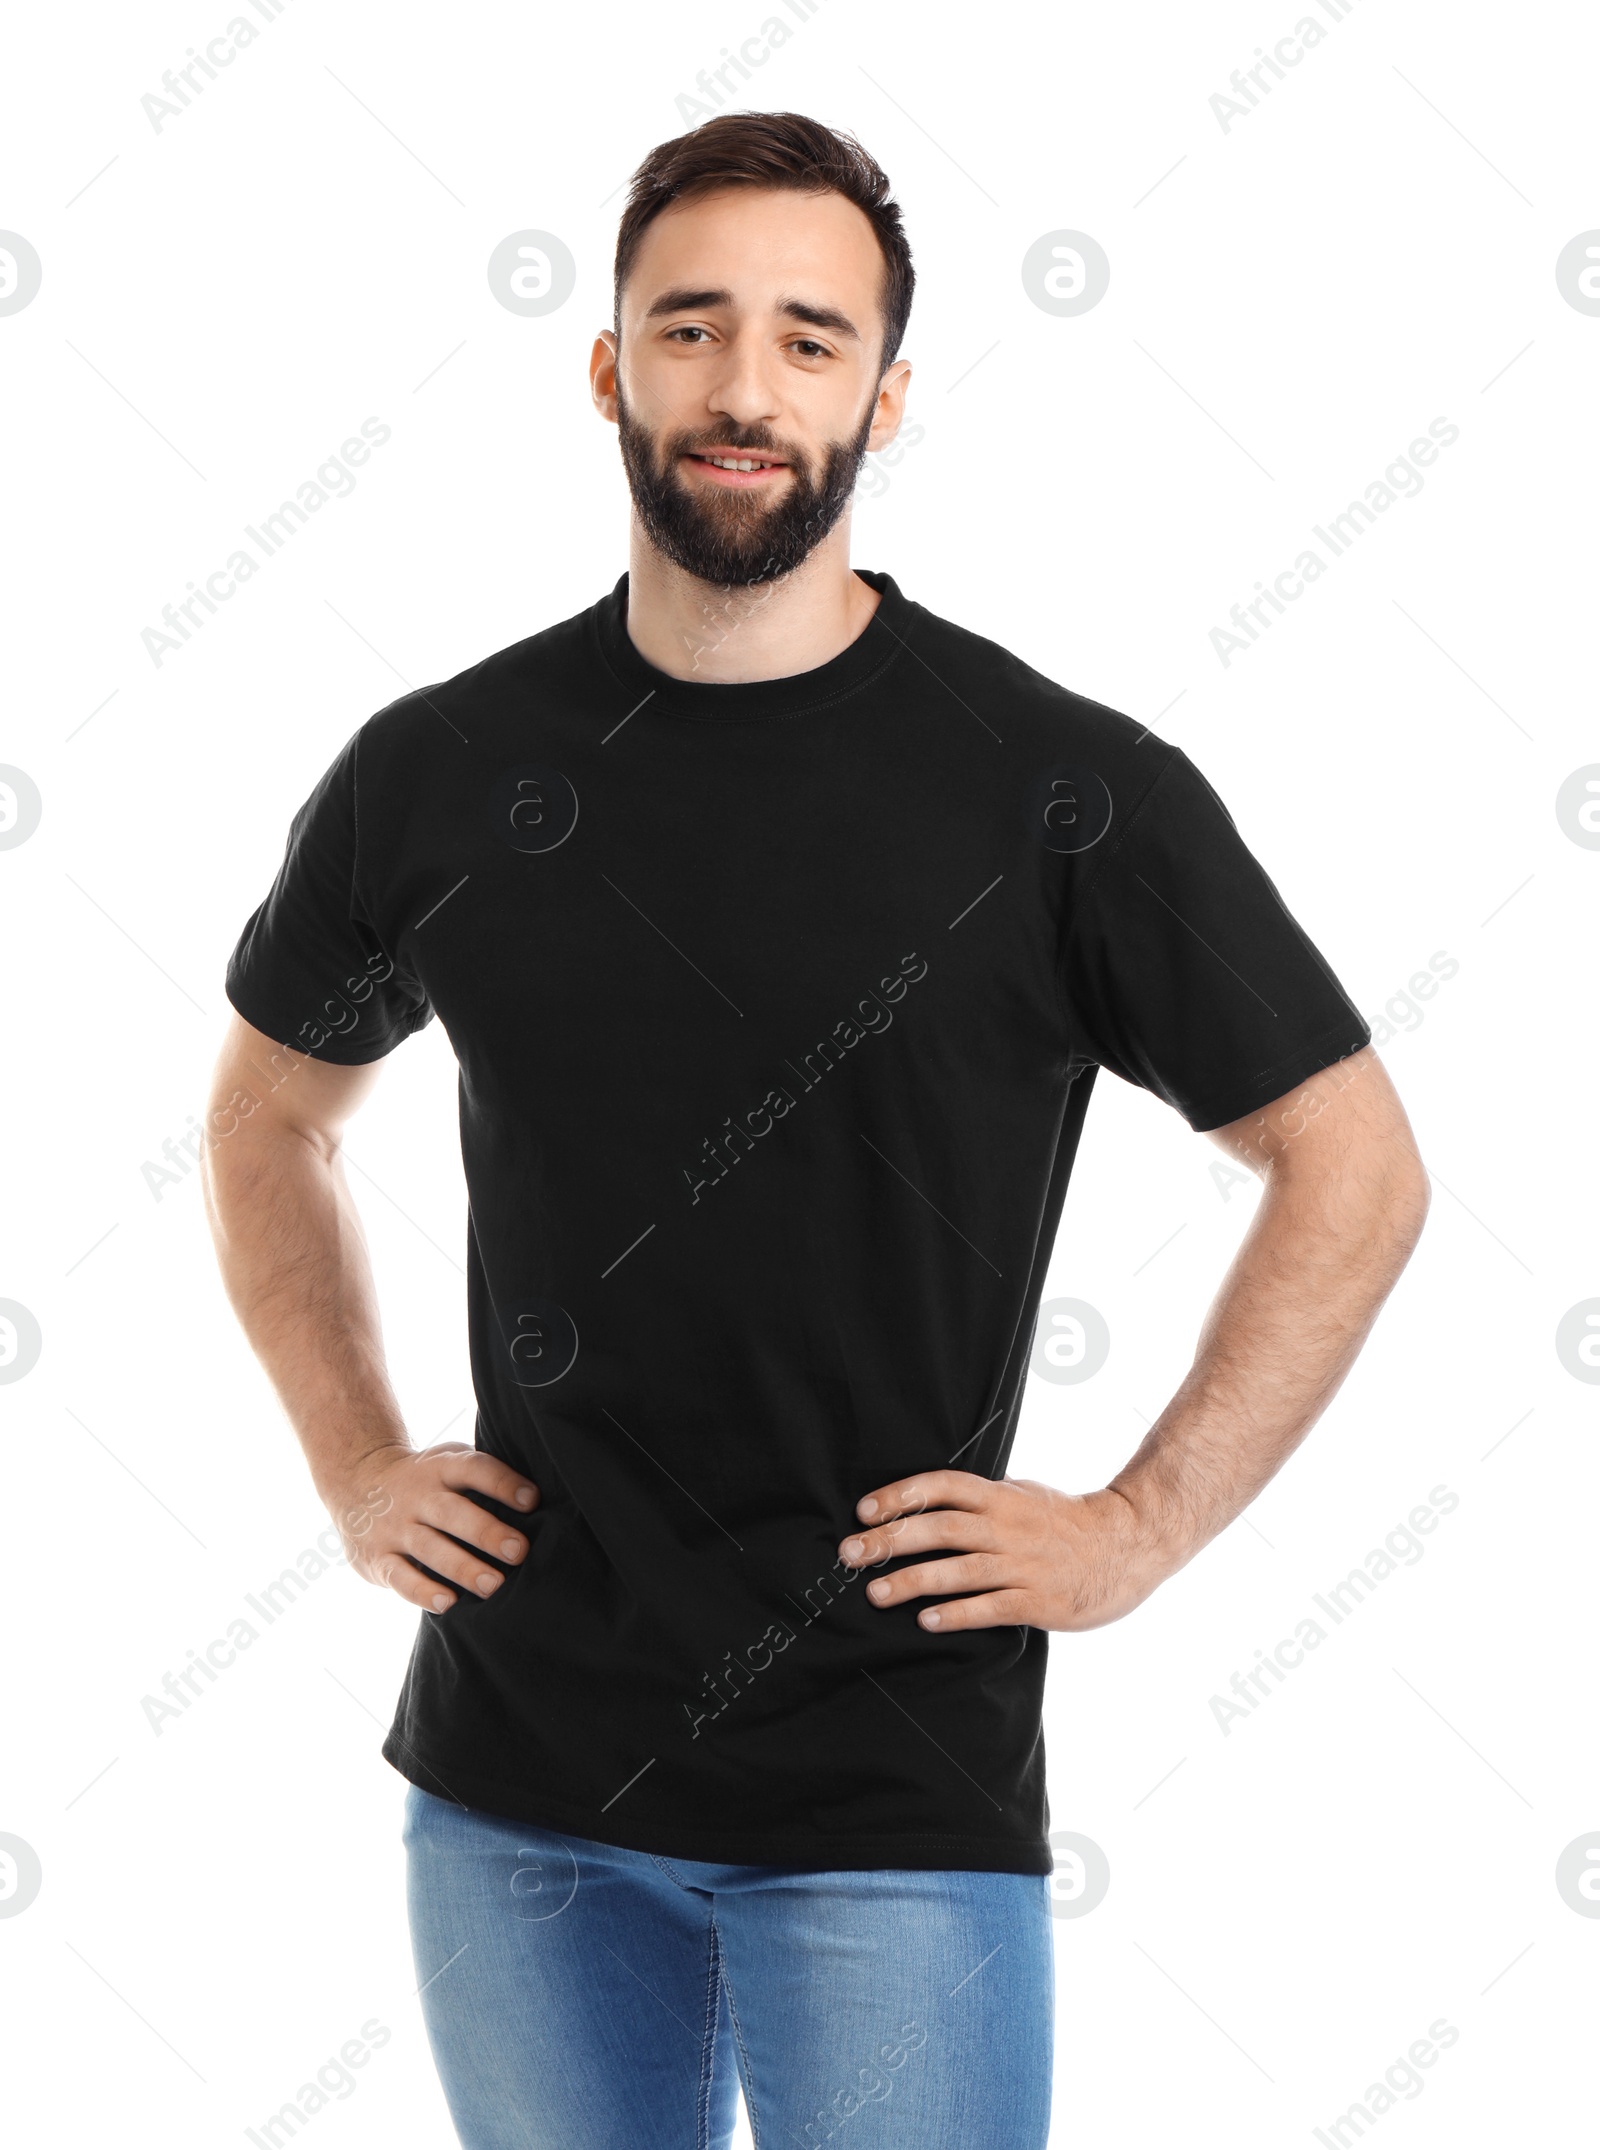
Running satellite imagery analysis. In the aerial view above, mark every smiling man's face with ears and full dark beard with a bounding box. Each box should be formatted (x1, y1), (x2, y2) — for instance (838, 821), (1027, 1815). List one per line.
(596, 187), (910, 585)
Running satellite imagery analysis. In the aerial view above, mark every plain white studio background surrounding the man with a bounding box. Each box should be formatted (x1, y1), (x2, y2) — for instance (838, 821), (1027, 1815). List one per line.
(0, 0), (1600, 2150)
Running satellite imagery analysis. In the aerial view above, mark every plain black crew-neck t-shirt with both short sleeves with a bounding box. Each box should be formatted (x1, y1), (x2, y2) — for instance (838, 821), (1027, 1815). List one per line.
(228, 574), (1370, 1873)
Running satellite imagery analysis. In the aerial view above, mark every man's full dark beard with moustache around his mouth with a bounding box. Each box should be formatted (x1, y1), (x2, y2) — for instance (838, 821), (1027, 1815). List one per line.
(617, 378), (875, 587)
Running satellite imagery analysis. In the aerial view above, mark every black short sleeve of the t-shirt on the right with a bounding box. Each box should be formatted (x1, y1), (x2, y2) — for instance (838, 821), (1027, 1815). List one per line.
(1060, 748), (1372, 1133)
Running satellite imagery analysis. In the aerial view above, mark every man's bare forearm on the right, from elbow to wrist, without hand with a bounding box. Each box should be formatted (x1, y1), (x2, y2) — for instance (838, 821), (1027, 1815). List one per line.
(1112, 1150), (1428, 1574)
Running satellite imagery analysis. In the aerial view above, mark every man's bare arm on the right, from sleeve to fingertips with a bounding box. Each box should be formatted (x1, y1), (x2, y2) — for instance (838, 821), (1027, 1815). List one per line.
(839, 1047), (1430, 1630)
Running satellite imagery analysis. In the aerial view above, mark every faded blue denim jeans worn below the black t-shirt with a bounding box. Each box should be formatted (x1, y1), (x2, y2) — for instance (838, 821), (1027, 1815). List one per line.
(404, 1785), (1056, 2150)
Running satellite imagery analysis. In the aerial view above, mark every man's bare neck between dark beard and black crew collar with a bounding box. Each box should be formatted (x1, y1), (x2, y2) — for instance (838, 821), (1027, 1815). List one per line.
(628, 516), (877, 686)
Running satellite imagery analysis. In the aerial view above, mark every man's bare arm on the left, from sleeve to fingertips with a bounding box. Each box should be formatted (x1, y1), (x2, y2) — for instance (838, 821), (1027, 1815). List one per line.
(202, 1015), (538, 1613)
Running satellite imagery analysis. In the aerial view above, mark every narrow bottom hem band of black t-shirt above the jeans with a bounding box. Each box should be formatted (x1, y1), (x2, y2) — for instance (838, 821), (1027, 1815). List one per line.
(383, 1731), (1056, 1875)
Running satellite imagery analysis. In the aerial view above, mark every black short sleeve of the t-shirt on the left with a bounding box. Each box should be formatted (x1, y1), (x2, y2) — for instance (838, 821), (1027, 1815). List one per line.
(226, 733), (432, 1066)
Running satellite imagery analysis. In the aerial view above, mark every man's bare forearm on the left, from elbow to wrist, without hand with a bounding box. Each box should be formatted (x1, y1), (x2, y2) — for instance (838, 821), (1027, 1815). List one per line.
(204, 1122), (409, 1507)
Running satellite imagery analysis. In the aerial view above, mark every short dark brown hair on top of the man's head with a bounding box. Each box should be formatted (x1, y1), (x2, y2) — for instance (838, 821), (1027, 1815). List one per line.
(611, 112), (916, 372)
